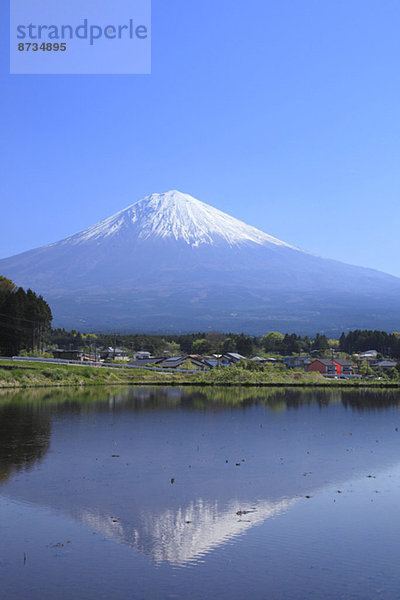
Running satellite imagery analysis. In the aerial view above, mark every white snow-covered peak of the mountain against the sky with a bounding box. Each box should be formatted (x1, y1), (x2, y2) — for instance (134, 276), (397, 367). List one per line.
(61, 190), (294, 248)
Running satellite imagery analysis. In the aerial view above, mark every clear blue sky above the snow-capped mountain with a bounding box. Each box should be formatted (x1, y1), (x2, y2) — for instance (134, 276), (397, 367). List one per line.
(0, 0), (400, 276)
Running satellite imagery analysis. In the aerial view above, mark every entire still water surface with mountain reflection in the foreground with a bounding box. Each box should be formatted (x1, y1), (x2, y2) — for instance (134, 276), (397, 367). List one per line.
(0, 388), (400, 600)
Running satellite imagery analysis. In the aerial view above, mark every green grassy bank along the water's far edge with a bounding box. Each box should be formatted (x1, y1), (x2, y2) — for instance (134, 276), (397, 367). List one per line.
(0, 360), (400, 389)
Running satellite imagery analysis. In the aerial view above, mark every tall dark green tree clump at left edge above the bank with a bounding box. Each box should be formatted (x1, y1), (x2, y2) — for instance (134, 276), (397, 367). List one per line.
(0, 276), (53, 356)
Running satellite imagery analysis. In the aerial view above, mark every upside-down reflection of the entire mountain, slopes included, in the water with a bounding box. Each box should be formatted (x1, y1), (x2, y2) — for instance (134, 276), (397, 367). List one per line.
(0, 388), (400, 565)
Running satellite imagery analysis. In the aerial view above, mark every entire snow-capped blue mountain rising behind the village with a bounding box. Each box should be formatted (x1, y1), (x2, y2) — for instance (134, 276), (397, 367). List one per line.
(0, 191), (400, 335)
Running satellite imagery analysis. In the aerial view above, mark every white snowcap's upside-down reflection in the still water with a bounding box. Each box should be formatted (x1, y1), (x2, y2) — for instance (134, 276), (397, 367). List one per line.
(80, 498), (299, 566)
